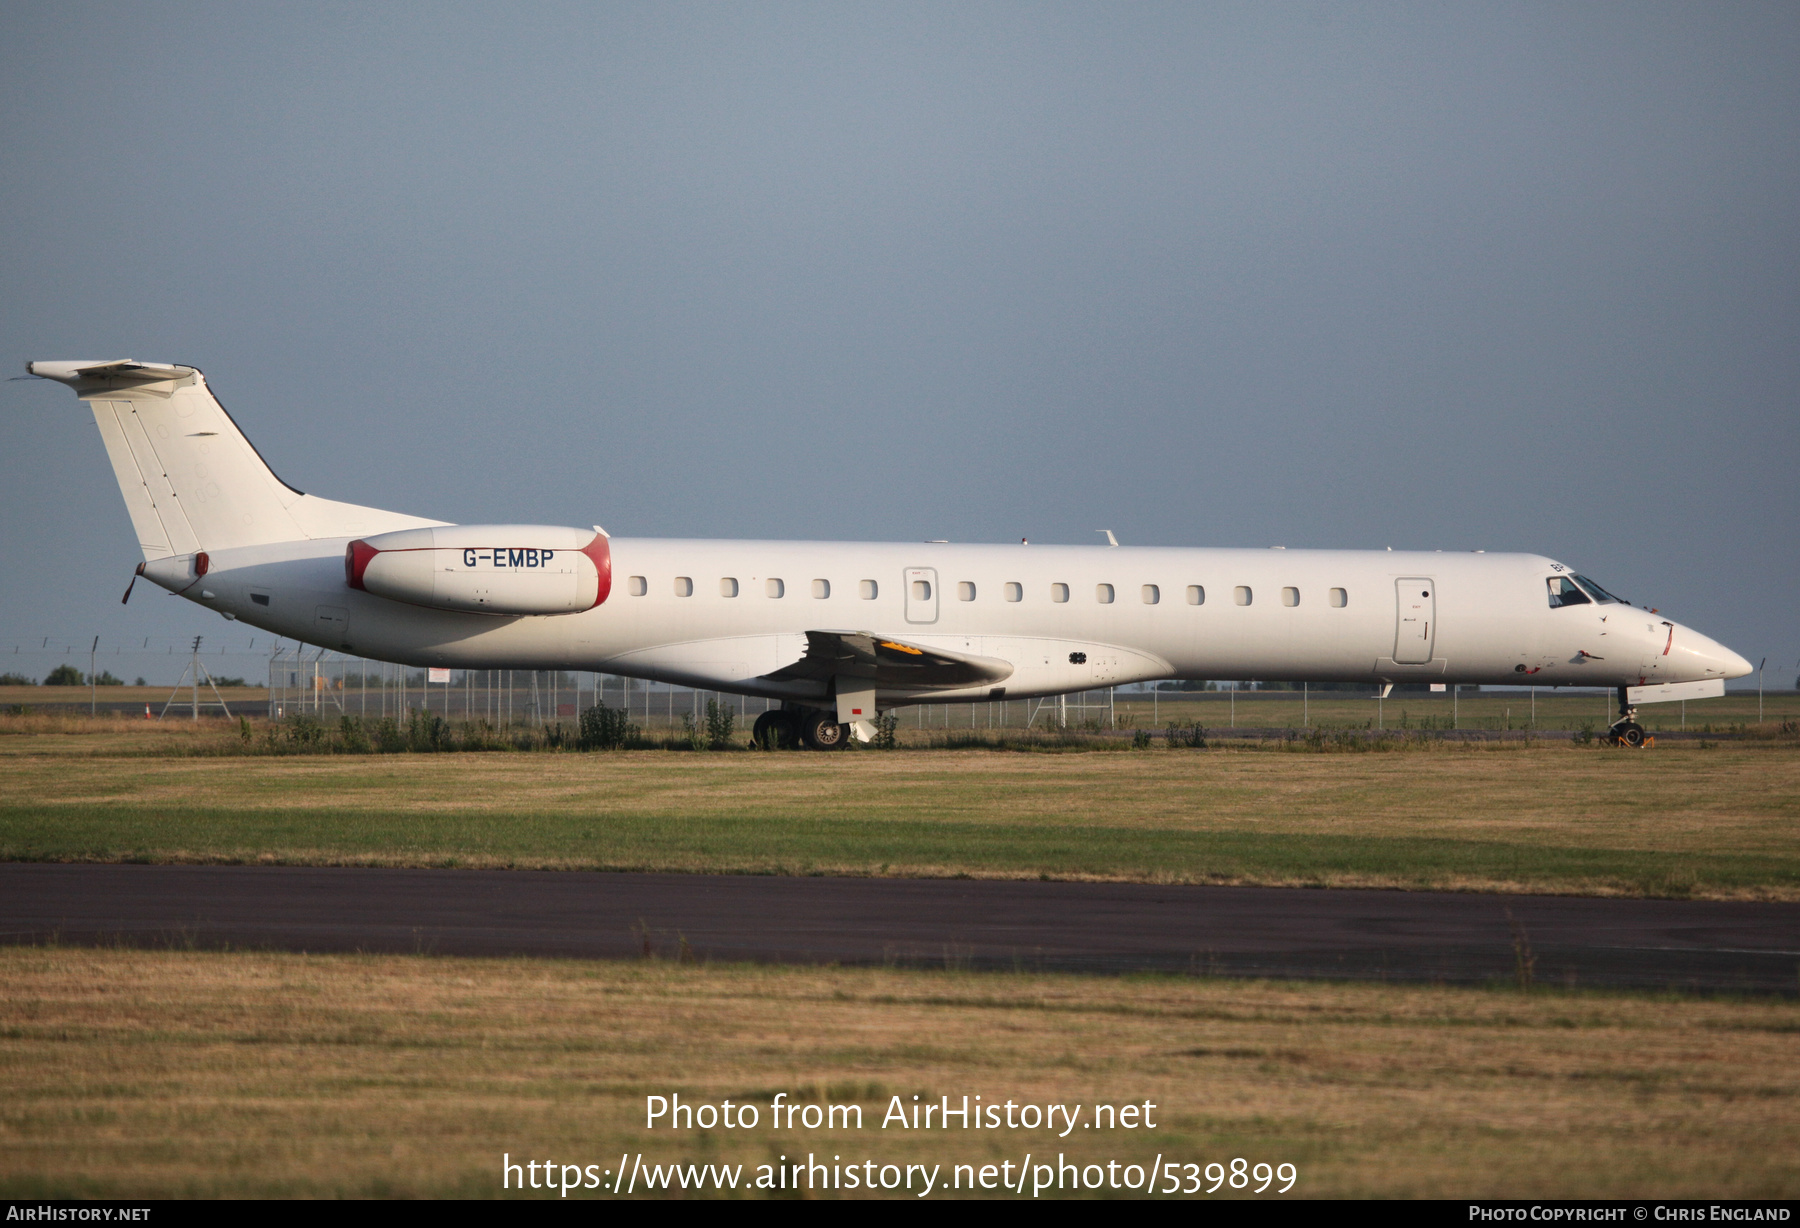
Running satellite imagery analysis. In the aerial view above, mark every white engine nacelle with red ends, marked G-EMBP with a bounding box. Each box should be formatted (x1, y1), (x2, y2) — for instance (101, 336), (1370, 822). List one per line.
(344, 524), (612, 614)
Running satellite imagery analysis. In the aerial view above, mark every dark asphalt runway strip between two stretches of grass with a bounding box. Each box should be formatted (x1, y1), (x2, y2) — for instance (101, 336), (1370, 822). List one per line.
(0, 862), (1800, 996)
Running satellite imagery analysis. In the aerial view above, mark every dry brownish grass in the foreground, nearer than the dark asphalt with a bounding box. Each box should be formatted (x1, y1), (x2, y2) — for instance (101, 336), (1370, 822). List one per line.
(0, 949), (1800, 1197)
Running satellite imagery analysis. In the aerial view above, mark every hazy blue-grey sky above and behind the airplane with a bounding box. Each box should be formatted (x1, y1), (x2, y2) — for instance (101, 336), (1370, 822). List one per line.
(0, 2), (1800, 686)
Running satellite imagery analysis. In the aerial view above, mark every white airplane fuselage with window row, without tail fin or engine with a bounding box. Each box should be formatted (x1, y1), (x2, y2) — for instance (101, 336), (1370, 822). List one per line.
(146, 538), (1735, 706)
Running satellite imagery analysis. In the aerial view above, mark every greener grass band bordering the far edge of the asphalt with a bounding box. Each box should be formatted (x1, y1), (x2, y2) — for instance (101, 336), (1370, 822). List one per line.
(0, 805), (1800, 898)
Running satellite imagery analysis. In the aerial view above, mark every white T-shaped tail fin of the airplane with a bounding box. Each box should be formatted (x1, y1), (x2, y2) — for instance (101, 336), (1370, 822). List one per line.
(25, 360), (441, 560)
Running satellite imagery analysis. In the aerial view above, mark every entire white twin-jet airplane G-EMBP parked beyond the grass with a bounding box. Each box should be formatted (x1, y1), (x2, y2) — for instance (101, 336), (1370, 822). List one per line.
(27, 360), (1751, 749)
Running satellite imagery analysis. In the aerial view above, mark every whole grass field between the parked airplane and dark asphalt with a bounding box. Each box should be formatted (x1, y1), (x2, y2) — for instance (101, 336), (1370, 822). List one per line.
(0, 718), (1800, 900)
